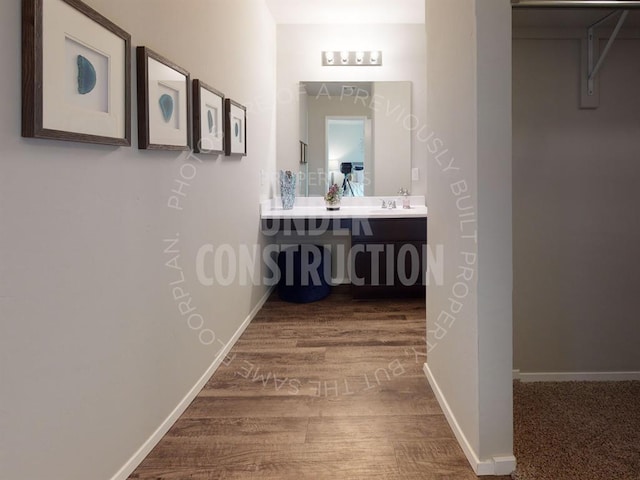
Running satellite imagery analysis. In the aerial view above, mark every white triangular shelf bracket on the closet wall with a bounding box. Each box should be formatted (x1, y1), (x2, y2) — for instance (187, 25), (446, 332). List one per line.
(581, 10), (629, 108)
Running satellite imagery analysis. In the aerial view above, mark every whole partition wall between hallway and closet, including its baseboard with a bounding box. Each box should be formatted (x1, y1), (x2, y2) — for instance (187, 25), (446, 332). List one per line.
(425, 0), (514, 474)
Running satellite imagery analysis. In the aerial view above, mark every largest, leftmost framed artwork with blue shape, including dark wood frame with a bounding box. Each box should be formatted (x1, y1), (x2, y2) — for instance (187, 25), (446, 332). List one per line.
(22, 0), (131, 146)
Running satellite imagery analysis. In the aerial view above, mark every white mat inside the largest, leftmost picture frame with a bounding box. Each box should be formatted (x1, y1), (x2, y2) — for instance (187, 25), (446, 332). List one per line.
(42, 0), (126, 138)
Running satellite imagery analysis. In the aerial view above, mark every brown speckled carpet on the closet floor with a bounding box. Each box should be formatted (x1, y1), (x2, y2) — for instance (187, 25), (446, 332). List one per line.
(513, 382), (640, 480)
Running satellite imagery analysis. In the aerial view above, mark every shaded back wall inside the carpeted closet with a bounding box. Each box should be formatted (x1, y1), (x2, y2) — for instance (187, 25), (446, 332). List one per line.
(513, 29), (640, 373)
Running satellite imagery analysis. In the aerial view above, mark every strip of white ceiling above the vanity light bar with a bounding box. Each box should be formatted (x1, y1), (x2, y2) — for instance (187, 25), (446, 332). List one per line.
(267, 0), (425, 24)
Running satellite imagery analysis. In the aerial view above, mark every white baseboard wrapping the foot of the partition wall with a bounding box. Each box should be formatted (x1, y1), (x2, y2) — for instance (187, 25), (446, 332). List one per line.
(423, 363), (516, 475)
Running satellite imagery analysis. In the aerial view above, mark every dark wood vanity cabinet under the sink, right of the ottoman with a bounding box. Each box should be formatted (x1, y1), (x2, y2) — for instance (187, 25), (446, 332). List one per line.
(350, 217), (427, 298)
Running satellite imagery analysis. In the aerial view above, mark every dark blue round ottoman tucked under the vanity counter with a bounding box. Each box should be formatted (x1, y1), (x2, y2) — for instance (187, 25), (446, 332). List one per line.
(278, 245), (331, 303)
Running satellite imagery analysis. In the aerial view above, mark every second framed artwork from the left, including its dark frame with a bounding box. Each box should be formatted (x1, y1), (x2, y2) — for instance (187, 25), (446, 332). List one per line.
(136, 47), (191, 150)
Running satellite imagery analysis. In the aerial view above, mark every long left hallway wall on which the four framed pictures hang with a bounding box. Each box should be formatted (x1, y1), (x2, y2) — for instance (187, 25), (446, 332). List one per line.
(0, 0), (276, 480)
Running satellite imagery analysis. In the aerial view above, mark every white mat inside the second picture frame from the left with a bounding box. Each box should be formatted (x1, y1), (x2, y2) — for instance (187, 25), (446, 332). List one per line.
(147, 57), (189, 147)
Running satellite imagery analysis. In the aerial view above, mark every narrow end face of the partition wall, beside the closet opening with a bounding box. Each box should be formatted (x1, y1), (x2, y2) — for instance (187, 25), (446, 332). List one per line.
(476, 0), (515, 464)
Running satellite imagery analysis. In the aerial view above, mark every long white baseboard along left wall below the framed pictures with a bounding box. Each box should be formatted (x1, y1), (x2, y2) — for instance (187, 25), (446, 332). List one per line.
(111, 287), (275, 480)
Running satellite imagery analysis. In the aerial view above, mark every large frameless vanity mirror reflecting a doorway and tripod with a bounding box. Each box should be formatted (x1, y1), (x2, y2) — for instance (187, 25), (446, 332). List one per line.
(299, 81), (411, 196)
